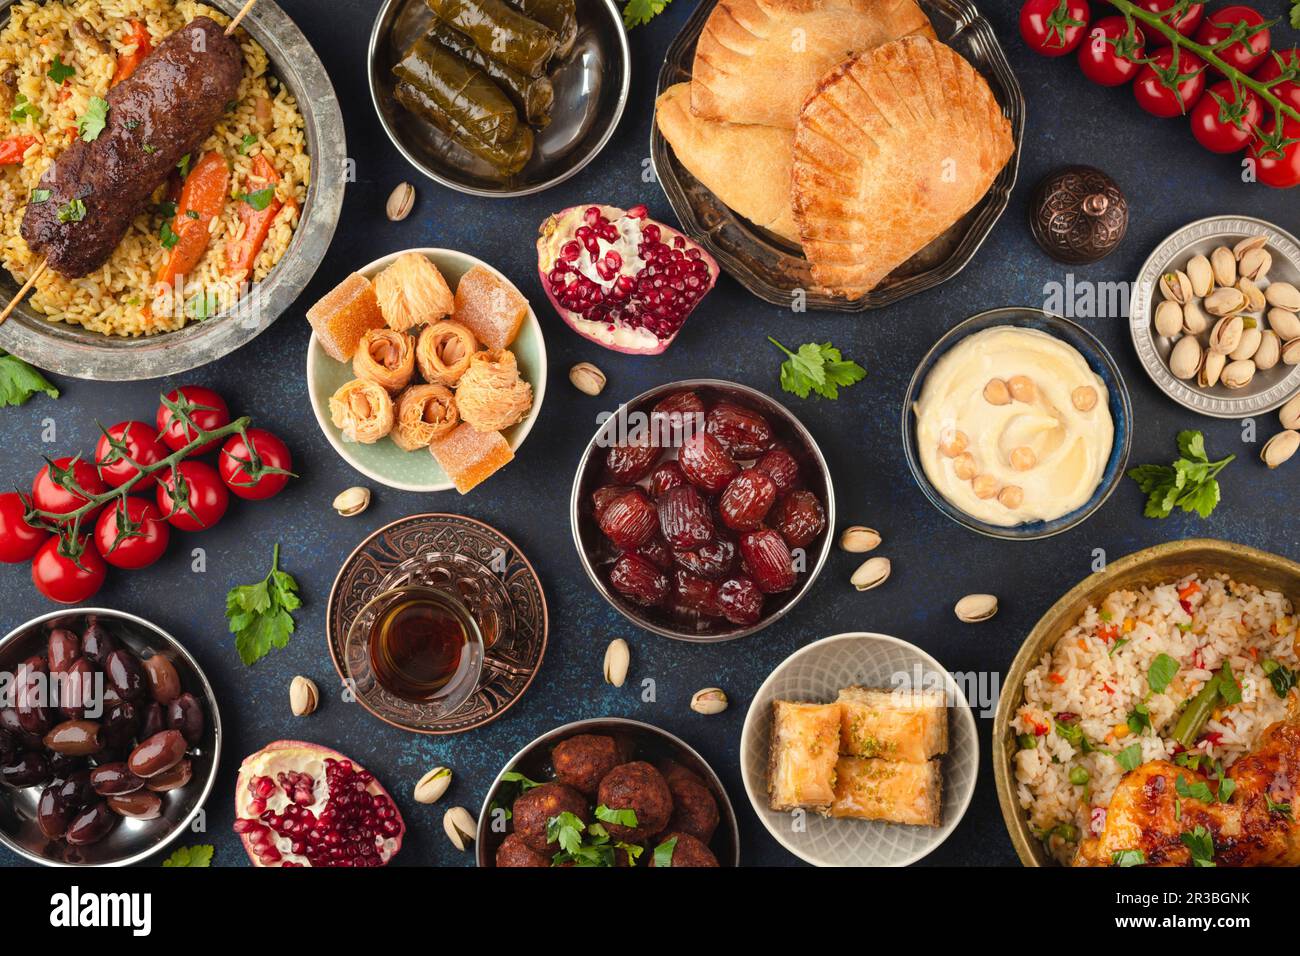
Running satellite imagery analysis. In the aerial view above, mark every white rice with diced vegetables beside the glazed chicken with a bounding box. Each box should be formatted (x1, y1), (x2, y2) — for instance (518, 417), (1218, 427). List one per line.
(1011, 575), (1300, 864)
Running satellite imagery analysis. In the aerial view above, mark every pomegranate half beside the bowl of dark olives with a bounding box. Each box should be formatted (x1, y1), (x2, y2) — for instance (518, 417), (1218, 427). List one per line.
(234, 740), (406, 866)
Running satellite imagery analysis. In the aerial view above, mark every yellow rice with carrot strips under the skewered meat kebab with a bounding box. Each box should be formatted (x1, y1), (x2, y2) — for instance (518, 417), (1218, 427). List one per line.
(0, 0), (311, 336)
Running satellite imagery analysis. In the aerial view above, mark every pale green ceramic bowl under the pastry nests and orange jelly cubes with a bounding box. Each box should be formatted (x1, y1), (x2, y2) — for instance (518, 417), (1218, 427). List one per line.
(307, 248), (546, 492)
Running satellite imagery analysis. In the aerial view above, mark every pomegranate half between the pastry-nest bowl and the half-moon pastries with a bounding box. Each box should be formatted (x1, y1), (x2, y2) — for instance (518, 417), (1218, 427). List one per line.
(537, 206), (718, 355)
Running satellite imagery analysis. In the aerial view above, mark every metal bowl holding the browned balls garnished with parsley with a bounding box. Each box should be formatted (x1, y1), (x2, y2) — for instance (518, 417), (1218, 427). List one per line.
(475, 717), (740, 866)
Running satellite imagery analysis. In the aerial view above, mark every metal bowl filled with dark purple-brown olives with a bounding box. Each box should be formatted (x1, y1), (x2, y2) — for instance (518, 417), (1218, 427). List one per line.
(0, 607), (221, 866)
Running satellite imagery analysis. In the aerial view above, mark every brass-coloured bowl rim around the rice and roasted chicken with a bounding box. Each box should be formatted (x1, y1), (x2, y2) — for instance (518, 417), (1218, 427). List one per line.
(993, 538), (1300, 866)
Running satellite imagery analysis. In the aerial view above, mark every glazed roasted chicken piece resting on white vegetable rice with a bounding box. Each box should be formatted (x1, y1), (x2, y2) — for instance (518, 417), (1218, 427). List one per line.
(1074, 693), (1300, 866)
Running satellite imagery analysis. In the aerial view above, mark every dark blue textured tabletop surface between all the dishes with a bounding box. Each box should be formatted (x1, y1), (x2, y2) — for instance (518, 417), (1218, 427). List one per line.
(0, 0), (1300, 865)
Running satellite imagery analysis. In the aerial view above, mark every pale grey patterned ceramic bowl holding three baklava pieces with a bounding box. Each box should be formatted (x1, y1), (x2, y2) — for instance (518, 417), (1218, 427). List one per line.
(740, 632), (979, 866)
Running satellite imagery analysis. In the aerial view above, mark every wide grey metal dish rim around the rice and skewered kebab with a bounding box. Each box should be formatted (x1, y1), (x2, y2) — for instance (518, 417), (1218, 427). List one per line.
(0, 0), (347, 381)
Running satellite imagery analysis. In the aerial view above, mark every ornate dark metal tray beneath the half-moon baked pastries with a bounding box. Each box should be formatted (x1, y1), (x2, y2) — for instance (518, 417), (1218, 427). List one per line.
(650, 0), (1024, 312)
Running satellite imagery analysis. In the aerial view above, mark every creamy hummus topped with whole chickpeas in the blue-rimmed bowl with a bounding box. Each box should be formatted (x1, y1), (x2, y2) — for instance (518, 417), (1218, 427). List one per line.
(914, 326), (1115, 527)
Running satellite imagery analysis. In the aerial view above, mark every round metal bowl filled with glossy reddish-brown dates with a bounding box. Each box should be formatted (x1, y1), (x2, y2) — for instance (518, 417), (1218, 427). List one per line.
(569, 378), (835, 643)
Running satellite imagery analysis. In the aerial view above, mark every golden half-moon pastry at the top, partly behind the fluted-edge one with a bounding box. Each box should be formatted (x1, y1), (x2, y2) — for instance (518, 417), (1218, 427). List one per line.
(690, 0), (935, 129)
